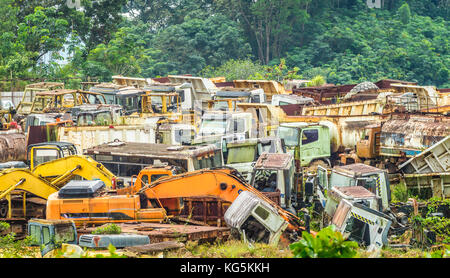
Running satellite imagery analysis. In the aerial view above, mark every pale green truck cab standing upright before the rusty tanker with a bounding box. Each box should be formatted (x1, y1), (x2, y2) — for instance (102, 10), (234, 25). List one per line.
(277, 122), (331, 169)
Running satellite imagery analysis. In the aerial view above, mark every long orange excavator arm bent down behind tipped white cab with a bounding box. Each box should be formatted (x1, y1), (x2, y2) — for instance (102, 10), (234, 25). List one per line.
(138, 169), (305, 231)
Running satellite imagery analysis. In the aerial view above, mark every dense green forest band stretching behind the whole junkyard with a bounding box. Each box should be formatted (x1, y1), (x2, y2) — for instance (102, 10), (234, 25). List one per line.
(0, 0), (450, 88)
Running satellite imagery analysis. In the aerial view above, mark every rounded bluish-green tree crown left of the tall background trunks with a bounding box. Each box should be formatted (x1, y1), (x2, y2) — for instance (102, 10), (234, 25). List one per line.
(151, 15), (251, 74)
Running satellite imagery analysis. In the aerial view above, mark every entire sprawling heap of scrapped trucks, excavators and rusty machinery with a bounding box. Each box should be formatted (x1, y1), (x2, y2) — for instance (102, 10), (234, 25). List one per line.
(0, 76), (450, 254)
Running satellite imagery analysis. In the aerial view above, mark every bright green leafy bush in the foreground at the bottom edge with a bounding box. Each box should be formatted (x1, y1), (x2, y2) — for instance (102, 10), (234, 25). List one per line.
(289, 226), (358, 258)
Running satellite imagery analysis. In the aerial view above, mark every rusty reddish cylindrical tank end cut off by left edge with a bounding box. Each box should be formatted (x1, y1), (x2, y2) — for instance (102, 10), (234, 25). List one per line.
(0, 132), (27, 162)
